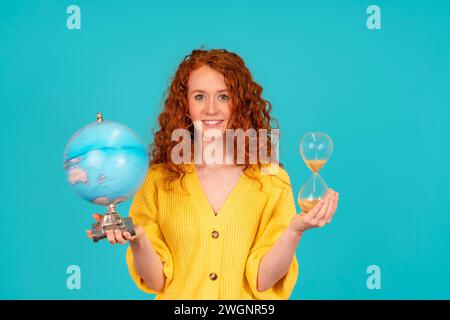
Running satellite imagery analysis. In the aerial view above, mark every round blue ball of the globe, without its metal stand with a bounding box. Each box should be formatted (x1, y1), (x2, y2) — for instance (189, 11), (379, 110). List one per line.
(64, 121), (149, 206)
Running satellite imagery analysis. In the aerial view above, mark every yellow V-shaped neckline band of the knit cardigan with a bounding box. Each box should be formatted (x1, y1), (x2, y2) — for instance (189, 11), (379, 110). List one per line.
(192, 164), (247, 218)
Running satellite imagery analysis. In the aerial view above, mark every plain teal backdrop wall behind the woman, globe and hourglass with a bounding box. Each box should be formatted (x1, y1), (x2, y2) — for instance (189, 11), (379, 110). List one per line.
(0, 0), (450, 299)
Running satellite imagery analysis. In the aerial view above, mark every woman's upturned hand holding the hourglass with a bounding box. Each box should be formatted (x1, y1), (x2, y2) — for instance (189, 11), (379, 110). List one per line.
(289, 188), (339, 234)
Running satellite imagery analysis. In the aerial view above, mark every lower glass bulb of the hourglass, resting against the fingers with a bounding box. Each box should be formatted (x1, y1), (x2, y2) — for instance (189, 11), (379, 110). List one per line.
(297, 174), (328, 212)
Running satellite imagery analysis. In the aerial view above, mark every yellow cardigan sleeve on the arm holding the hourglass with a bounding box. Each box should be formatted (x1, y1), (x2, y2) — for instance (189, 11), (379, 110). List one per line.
(245, 171), (298, 300)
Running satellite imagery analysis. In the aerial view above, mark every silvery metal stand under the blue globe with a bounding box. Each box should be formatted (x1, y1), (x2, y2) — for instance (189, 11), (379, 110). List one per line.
(92, 204), (136, 242)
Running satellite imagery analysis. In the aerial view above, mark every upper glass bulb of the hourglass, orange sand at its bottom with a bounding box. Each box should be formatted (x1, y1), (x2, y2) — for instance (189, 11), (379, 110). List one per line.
(300, 132), (333, 173)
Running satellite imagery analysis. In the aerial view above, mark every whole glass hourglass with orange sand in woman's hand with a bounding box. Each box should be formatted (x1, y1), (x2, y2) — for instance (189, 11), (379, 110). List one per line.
(298, 132), (333, 213)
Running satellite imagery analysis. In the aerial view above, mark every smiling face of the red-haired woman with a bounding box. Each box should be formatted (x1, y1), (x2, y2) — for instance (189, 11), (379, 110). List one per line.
(188, 65), (232, 139)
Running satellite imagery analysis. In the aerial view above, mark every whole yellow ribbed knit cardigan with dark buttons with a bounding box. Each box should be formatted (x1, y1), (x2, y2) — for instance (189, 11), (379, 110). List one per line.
(126, 164), (298, 300)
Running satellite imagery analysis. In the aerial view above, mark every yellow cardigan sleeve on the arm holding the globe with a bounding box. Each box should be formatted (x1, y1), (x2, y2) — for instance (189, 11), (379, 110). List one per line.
(126, 169), (173, 294)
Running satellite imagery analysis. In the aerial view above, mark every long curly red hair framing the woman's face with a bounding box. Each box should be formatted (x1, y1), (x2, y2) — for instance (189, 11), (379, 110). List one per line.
(150, 49), (281, 190)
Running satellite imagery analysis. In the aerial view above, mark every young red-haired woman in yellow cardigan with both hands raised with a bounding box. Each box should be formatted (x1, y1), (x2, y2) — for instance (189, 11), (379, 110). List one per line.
(88, 50), (338, 299)
